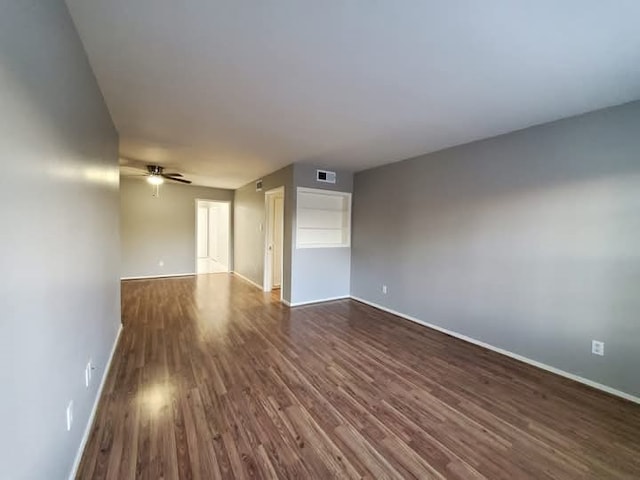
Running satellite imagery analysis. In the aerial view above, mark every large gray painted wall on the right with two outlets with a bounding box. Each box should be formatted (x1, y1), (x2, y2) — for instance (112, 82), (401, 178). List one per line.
(351, 102), (640, 396)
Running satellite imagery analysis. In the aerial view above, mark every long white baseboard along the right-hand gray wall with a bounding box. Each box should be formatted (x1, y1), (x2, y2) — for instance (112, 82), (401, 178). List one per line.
(351, 295), (640, 404)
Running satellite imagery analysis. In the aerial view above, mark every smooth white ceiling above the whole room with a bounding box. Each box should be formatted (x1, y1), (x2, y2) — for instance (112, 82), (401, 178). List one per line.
(67, 0), (640, 188)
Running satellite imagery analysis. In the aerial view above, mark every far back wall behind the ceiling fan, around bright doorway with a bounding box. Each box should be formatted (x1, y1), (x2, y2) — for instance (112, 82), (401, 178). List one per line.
(120, 178), (233, 278)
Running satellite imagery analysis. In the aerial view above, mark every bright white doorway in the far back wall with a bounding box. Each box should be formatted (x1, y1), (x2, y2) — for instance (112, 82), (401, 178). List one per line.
(196, 200), (231, 274)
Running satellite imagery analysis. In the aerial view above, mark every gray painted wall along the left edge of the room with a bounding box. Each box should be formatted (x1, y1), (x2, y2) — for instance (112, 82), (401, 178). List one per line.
(0, 0), (120, 480)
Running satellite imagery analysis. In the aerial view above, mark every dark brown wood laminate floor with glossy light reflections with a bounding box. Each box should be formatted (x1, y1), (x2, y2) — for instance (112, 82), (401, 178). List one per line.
(78, 274), (640, 480)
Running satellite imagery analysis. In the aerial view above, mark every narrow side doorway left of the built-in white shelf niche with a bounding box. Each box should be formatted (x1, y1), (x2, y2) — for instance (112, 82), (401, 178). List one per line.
(264, 187), (284, 299)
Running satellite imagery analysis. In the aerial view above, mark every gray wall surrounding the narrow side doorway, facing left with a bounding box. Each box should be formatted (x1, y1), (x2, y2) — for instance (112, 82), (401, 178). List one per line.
(233, 165), (294, 301)
